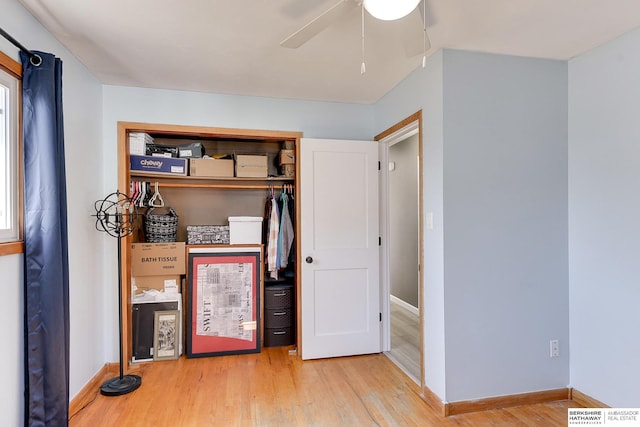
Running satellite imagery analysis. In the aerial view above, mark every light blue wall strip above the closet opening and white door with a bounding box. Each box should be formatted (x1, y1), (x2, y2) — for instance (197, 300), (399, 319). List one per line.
(104, 86), (373, 139)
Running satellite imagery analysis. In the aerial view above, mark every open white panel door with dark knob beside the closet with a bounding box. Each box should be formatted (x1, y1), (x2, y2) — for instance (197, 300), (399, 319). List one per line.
(300, 138), (381, 359)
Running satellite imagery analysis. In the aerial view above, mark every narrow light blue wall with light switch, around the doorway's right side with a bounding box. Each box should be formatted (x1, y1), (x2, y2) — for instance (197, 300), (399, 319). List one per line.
(374, 51), (446, 399)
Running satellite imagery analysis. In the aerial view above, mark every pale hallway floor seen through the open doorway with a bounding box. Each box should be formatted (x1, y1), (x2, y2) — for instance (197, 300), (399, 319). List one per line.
(387, 300), (420, 384)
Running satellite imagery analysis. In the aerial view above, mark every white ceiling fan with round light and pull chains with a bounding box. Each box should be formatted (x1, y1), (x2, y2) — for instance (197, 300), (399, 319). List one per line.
(280, 0), (433, 57)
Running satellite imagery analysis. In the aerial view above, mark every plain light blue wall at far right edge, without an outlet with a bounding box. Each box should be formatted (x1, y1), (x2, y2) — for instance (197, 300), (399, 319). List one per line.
(569, 24), (640, 408)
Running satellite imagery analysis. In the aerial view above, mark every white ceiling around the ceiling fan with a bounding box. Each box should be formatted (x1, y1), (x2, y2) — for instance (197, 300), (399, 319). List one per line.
(20, 0), (640, 104)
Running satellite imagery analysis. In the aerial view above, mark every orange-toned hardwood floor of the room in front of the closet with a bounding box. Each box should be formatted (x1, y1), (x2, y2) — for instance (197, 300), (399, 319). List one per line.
(69, 347), (578, 427)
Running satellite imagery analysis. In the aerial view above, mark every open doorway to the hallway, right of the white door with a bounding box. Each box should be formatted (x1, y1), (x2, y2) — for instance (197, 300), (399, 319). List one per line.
(376, 112), (424, 387)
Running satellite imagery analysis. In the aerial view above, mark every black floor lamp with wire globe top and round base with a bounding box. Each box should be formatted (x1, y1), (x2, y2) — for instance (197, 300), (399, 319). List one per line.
(95, 191), (142, 396)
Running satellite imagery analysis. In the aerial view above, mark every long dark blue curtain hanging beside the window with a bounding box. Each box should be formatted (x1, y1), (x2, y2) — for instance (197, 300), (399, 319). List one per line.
(21, 52), (69, 426)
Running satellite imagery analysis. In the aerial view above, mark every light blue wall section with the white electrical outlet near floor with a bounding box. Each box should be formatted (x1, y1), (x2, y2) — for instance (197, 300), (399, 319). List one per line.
(444, 50), (569, 401)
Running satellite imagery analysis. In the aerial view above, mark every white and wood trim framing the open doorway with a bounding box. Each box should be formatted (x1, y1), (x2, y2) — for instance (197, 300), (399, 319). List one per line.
(374, 110), (425, 389)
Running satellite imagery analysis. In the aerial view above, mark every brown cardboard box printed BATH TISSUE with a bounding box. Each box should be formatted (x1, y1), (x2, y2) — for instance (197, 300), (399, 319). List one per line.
(131, 242), (186, 277)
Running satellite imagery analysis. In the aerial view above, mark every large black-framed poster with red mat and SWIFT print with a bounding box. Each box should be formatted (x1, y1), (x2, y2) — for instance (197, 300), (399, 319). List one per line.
(187, 245), (263, 357)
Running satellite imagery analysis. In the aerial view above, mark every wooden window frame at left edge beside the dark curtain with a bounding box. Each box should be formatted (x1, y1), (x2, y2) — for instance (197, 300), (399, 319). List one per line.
(0, 51), (24, 256)
